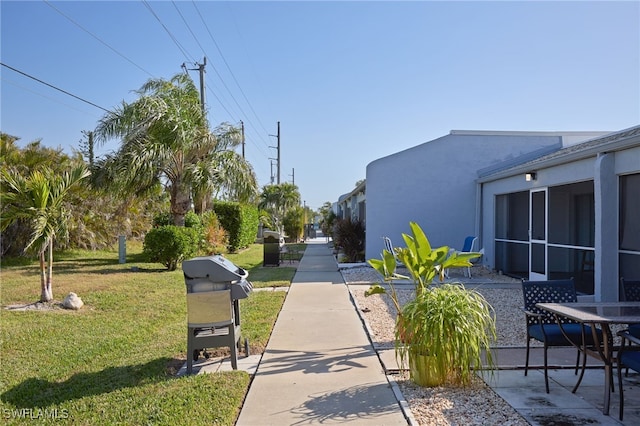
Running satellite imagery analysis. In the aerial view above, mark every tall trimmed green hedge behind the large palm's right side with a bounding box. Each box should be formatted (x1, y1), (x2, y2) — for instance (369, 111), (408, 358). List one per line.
(213, 201), (259, 252)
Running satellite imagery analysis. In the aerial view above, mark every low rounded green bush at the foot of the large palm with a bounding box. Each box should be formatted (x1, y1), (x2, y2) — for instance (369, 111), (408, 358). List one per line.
(142, 225), (201, 271)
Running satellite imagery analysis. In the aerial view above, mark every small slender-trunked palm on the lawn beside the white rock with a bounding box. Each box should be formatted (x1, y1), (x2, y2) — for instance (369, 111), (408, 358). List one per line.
(0, 164), (90, 302)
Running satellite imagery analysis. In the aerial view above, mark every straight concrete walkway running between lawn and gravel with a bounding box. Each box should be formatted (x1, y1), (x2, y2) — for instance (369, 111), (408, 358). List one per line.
(236, 239), (407, 426)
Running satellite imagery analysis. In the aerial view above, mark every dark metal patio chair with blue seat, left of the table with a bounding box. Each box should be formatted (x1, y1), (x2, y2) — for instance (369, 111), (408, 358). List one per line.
(522, 278), (601, 393)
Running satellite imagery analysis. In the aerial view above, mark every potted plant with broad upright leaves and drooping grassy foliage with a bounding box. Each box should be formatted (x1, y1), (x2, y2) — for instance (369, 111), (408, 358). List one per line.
(365, 222), (496, 386)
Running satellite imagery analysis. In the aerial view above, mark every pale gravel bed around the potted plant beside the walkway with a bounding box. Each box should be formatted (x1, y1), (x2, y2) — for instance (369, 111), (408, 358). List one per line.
(341, 266), (529, 426)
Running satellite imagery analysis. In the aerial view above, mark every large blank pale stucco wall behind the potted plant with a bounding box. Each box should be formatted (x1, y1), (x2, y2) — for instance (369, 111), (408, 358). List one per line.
(366, 132), (561, 259)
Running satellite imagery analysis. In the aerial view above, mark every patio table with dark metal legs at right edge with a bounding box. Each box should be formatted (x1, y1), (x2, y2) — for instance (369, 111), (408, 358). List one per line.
(536, 302), (640, 415)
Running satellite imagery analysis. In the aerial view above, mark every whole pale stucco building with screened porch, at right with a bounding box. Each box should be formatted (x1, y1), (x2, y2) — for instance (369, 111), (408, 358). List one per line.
(361, 126), (640, 300)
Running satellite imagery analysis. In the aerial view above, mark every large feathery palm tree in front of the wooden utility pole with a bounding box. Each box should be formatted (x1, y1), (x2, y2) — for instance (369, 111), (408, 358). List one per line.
(95, 74), (257, 225)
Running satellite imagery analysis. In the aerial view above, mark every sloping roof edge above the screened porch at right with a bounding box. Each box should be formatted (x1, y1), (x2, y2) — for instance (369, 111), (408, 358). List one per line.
(478, 125), (640, 183)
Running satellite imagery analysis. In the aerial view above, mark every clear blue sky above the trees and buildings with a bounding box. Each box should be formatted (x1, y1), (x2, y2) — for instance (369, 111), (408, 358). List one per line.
(0, 0), (640, 209)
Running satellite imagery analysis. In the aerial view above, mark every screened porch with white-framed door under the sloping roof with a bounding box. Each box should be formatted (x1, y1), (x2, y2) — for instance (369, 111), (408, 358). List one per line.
(479, 126), (640, 301)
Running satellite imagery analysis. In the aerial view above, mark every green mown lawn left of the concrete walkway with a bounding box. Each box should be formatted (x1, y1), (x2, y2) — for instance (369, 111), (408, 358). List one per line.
(0, 244), (304, 425)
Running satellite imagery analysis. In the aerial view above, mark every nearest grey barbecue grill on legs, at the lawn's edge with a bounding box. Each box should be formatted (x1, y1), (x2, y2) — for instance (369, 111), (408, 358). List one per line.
(182, 256), (253, 374)
